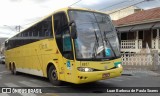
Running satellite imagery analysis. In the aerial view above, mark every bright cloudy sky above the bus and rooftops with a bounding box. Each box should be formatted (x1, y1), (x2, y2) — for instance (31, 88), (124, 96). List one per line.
(0, 0), (160, 37)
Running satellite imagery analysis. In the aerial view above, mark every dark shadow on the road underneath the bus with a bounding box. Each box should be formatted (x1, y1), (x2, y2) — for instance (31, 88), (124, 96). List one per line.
(8, 73), (116, 93)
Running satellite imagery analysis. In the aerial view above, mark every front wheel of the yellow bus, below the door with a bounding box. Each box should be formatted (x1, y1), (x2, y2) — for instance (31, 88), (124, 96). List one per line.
(48, 66), (61, 85)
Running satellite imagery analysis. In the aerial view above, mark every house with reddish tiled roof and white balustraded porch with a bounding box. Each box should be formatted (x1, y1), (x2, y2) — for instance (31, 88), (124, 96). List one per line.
(114, 7), (160, 52)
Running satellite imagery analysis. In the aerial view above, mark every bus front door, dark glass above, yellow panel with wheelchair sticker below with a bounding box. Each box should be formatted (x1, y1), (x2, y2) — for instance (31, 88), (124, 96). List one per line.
(53, 12), (75, 81)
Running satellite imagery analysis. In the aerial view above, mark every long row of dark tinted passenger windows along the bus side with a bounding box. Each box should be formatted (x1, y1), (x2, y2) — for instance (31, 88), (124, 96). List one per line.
(7, 16), (53, 49)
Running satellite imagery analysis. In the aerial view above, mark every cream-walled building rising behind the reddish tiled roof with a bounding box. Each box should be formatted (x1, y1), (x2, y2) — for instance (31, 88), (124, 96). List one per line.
(106, 6), (143, 20)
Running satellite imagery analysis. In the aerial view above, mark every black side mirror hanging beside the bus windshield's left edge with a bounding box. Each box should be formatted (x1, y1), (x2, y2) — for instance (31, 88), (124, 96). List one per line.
(69, 20), (77, 39)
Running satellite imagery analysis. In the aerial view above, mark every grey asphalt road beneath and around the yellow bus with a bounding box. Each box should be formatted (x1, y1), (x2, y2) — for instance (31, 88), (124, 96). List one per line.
(0, 64), (160, 96)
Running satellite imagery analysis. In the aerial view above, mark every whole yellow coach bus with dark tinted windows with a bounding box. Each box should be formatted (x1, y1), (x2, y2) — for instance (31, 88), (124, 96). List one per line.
(5, 8), (123, 85)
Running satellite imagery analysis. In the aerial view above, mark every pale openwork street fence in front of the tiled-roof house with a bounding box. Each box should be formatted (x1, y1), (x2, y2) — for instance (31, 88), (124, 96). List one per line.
(121, 51), (160, 70)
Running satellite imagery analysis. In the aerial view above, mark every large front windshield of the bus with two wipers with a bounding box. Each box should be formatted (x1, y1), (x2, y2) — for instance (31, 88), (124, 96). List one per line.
(69, 10), (120, 60)
